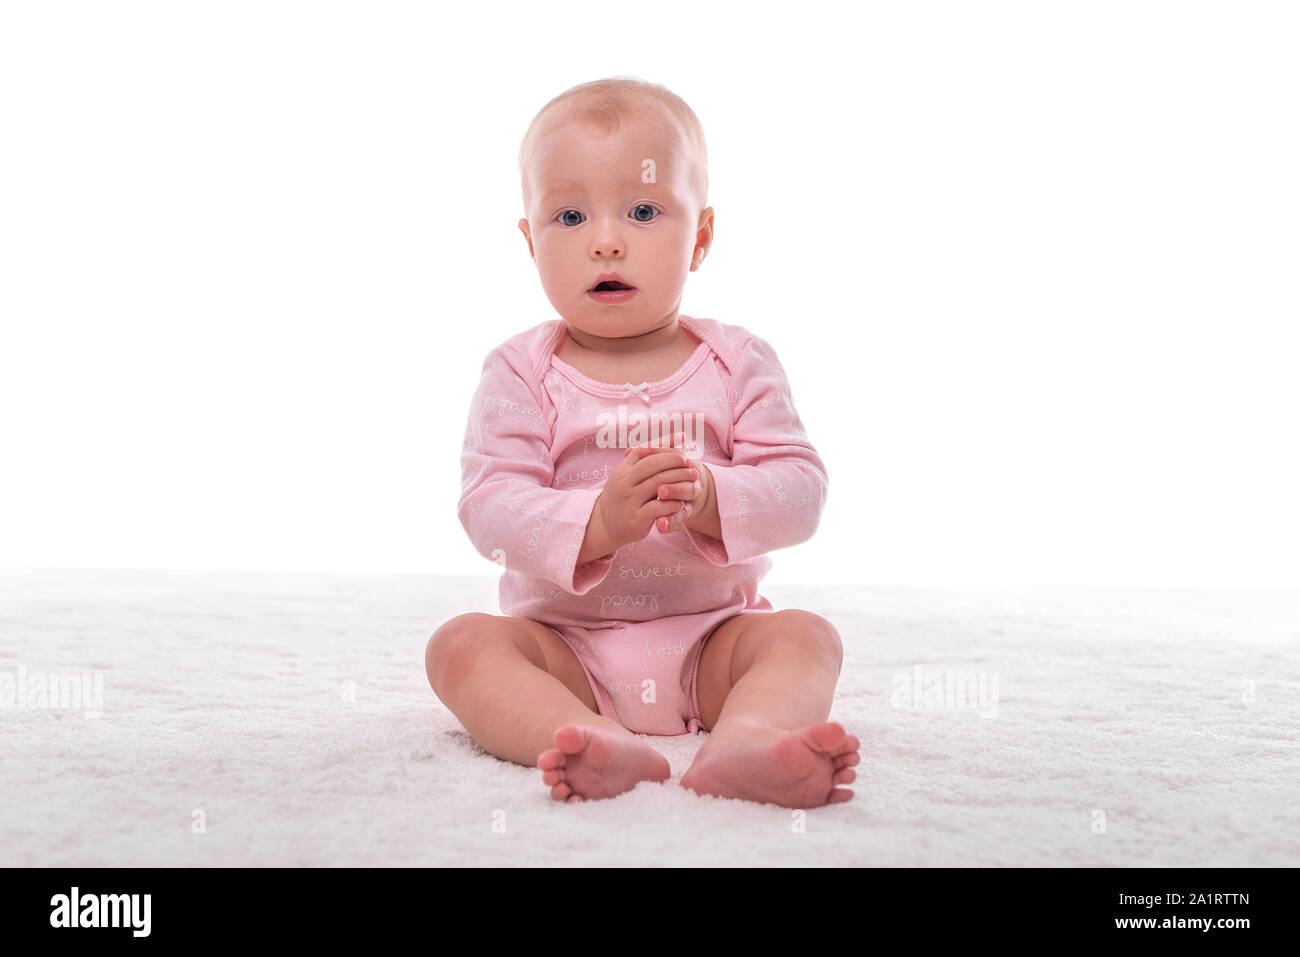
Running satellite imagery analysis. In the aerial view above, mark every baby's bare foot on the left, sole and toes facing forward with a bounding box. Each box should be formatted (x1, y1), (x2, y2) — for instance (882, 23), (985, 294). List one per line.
(537, 724), (672, 804)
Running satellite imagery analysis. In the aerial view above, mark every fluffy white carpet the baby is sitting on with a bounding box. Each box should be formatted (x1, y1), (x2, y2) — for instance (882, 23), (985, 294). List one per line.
(0, 571), (1300, 866)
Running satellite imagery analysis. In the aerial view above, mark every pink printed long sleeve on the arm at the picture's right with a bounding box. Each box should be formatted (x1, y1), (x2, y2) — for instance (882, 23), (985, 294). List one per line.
(686, 337), (829, 566)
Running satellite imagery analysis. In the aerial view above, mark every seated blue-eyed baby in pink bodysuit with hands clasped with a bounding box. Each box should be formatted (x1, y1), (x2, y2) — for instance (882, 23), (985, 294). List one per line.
(425, 78), (858, 807)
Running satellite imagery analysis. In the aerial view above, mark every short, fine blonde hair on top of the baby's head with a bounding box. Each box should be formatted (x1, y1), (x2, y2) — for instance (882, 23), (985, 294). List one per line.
(519, 77), (709, 208)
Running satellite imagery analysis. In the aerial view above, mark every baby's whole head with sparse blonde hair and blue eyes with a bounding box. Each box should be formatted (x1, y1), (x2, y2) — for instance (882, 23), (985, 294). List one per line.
(519, 78), (714, 338)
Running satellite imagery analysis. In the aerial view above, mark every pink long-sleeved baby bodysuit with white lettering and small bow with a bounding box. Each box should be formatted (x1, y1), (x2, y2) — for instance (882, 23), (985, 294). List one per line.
(459, 315), (827, 735)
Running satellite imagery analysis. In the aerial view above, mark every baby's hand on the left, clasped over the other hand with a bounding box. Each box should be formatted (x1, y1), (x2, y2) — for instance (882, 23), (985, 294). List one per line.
(595, 433), (701, 547)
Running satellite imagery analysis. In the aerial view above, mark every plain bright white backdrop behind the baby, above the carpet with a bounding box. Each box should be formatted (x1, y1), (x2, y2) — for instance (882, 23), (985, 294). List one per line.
(0, 0), (1300, 588)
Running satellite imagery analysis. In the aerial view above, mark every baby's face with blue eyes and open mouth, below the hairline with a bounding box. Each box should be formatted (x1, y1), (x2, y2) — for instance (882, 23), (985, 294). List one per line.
(519, 110), (712, 338)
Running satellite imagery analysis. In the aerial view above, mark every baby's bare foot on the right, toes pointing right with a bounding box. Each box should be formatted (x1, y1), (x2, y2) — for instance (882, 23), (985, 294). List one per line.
(681, 722), (859, 807)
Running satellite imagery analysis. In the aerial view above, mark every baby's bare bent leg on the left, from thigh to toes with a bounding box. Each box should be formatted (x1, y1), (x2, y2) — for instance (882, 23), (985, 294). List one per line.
(425, 614), (671, 801)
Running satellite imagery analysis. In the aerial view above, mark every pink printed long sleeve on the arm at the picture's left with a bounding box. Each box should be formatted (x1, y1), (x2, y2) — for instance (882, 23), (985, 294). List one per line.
(456, 343), (614, 594)
